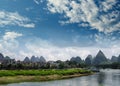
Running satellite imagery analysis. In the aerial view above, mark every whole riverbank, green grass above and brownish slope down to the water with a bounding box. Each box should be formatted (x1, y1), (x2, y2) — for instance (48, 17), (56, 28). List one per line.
(0, 69), (92, 84)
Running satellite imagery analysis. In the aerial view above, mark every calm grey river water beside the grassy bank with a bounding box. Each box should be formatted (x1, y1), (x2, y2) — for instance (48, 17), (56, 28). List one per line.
(2, 69), (120, 86)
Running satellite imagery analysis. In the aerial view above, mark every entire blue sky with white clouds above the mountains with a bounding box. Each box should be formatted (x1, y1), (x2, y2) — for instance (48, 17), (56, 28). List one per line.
(0, 0), (120, 60)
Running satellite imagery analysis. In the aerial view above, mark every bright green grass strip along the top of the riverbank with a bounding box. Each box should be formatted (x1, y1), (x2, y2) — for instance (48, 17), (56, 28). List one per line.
(0, 69), (91, 77)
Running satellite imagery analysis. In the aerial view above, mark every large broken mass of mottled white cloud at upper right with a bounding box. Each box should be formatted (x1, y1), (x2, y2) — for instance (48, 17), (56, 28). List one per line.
(47, 0), (120, 33)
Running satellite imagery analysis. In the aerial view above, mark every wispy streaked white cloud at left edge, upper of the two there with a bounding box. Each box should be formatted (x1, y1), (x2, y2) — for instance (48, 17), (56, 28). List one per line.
(0, 11), (35, 28)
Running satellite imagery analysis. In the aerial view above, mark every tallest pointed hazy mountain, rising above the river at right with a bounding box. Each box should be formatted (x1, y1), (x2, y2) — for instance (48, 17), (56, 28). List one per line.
(93, 50), (107, 65)
